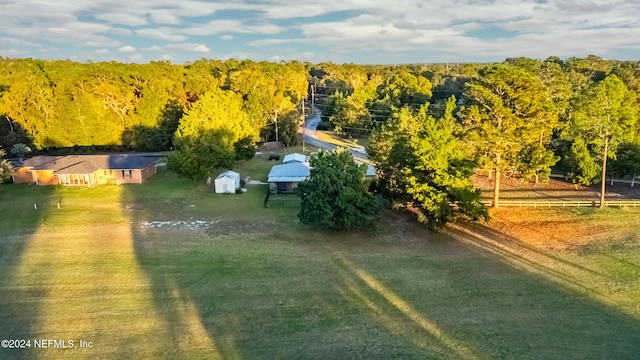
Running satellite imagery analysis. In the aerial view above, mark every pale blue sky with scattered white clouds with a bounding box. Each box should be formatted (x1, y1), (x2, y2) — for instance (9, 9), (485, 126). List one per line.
(0, 0), (640, 64)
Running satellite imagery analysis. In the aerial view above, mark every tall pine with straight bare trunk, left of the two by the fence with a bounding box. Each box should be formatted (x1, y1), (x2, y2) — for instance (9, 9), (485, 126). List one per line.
(461, 64), (558, 207)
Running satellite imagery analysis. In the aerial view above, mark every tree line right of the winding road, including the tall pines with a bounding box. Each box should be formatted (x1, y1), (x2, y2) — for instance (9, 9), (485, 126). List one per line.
(310, 56), (640, 221)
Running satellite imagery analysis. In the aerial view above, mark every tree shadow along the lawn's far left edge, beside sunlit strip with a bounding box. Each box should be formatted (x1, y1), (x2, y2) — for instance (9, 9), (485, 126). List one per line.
(0, 184), (56, 359)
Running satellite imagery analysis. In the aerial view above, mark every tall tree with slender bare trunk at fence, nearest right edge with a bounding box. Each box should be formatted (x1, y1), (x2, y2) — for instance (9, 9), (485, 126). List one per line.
(564, 75), (638, 208)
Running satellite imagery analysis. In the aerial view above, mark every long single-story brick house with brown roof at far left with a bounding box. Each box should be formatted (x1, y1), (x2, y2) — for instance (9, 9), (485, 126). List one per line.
(13, 154), (160, 186)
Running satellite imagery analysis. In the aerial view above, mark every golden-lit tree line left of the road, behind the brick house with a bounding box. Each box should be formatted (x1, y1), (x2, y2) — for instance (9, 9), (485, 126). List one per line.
(0, 58), (307, 155)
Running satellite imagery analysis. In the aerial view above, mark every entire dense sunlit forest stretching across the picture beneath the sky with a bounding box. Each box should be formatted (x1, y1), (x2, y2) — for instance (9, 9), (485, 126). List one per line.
(0, 56), (640, 218)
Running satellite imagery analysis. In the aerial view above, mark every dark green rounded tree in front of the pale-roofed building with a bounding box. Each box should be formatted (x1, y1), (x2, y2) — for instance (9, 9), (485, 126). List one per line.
(296, 149), (381, 229)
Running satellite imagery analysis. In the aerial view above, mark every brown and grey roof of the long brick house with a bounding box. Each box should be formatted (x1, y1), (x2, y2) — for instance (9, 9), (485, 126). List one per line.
(23, 154), (159, 174)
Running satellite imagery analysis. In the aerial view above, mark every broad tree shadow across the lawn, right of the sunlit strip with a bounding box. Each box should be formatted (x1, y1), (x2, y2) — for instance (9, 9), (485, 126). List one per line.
(123, 176), (640, 359)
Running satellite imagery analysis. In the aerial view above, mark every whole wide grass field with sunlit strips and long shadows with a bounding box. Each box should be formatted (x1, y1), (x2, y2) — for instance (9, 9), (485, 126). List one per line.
(0, 158), (640, 359)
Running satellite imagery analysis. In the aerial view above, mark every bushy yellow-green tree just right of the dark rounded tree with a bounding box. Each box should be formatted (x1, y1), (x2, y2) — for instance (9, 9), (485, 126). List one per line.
(367, 97), (488, 228)
